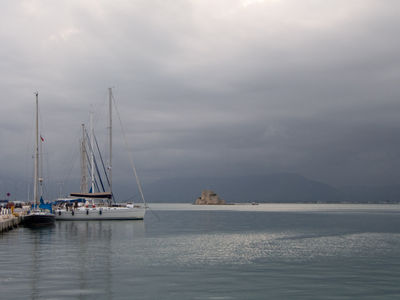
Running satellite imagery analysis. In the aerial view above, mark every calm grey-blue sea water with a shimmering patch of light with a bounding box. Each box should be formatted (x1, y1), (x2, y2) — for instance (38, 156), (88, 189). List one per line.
(0, 204), (400, 299)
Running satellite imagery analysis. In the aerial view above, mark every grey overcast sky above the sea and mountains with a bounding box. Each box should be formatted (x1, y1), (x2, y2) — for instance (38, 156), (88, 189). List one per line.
(0, 0), (400, 198)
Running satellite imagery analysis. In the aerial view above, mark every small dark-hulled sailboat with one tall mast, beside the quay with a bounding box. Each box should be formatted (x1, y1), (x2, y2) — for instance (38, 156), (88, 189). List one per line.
(23, 92), (55, 227)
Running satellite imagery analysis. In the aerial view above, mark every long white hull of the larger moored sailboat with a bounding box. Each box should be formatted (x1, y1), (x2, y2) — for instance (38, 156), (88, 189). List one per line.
(55, 207), (146, 221)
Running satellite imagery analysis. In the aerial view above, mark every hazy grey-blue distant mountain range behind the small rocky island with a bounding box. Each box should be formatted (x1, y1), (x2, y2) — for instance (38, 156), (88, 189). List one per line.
(141, 173), (400, 203)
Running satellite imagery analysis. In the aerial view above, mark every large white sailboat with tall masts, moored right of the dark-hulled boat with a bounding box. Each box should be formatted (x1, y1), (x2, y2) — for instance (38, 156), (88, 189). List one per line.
(55, 88), (146, 221)
